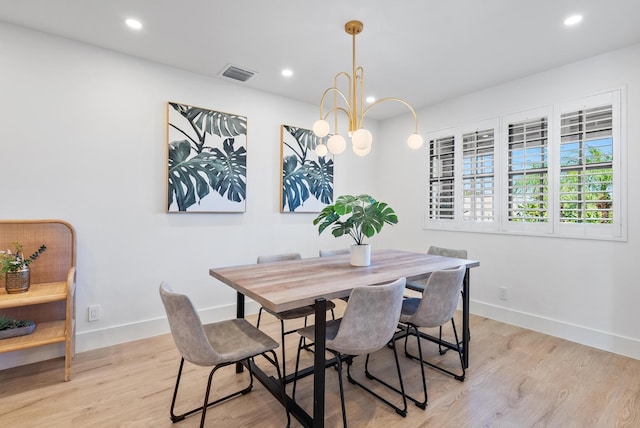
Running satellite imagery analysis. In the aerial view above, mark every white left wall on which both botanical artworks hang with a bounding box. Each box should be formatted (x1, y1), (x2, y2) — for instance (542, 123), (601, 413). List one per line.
(0, 24), (377, 368)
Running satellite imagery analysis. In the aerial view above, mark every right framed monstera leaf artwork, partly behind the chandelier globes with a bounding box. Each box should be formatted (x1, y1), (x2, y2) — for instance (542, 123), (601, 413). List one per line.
(280, 125), (333, 213)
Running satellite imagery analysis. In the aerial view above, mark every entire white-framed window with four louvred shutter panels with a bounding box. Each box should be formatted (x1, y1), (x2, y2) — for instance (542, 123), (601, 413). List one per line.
(425, 89), (627, 240)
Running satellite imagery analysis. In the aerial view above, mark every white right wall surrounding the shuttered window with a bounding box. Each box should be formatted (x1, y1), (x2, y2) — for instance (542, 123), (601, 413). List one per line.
(377, 45), (640, 358)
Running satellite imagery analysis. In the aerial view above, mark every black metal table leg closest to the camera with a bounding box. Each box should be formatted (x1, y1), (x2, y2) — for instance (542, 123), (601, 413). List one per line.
(313, 298), (327, 427)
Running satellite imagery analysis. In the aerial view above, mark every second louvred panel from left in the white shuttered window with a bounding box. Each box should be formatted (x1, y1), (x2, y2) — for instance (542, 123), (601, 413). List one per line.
(462, 129), (495, 221)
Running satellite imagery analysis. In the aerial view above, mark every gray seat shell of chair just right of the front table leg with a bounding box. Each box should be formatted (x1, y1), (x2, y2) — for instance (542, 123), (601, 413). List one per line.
(327, 278), (406, 355)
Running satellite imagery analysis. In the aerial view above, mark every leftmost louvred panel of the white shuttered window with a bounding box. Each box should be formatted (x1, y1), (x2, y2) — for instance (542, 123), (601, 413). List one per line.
(429, 135), (455, 220)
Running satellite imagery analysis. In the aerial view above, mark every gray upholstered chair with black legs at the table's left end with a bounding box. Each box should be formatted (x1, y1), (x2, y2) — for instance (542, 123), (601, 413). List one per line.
(160, 282), (291, 428)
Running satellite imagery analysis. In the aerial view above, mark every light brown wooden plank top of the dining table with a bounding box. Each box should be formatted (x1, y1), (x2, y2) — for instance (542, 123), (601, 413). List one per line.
(209, 250), (480, 312)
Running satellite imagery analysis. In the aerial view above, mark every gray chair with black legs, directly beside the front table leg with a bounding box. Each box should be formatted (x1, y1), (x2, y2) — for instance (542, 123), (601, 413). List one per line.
(292, 278), (407, 428)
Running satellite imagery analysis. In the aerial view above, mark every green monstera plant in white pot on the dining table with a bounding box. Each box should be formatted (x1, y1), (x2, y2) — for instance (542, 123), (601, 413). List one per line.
(313, 194), (398, 266)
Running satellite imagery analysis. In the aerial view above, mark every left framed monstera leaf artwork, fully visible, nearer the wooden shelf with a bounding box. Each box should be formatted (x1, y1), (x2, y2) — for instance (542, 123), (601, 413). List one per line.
(167, 102), (247, 212)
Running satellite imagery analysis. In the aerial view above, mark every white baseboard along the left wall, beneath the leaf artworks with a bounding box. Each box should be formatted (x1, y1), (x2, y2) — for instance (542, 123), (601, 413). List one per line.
(0, 301), (259, 373)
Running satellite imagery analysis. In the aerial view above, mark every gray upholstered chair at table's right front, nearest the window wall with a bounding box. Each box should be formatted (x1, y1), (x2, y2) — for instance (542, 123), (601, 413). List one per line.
(400, 265), (466, 409)
